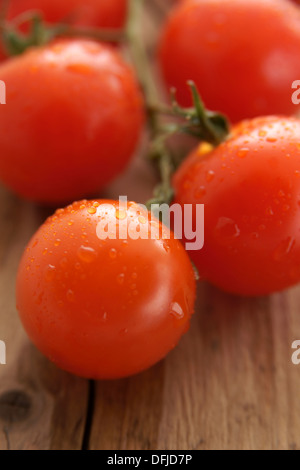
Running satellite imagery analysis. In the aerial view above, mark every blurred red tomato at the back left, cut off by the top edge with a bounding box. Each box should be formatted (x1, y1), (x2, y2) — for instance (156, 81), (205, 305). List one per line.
(8, 0), (127, 28)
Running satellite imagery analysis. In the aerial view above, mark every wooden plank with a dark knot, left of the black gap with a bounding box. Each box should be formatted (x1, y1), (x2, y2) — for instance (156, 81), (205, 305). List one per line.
(0, 187), (88, 450)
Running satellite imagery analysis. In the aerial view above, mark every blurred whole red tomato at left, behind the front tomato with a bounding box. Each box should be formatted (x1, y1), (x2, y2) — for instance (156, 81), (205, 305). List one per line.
(0, 40), (144, 203)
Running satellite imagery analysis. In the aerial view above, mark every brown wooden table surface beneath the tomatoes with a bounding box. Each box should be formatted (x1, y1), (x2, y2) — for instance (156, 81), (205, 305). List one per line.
(0, 0), (300, 450)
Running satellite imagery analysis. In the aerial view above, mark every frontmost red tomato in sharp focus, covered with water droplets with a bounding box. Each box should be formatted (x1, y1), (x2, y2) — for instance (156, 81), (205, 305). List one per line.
(17, 200), (195, 379)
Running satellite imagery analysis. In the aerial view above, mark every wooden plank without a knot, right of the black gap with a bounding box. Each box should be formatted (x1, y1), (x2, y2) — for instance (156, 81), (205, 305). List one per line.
(90, 284), (300, 450)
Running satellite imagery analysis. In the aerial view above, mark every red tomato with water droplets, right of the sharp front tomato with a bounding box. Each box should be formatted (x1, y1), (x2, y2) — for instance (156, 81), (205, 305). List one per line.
(174, 117), (300, 295)
